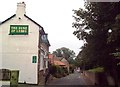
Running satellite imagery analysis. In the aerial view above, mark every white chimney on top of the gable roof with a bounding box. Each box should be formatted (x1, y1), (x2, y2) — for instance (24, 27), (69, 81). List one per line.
(16, 2), (26, 18)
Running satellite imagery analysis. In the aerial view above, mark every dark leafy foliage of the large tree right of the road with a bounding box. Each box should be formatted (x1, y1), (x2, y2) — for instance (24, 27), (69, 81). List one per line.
(73, 2), (120, 68)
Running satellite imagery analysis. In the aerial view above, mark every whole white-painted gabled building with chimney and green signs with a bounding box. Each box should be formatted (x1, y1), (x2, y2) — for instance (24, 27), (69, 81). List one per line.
(0, 2), (50, 84)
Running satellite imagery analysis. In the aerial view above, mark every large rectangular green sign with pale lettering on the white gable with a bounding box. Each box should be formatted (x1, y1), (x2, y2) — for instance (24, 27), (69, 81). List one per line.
(10, 25), (28, 35)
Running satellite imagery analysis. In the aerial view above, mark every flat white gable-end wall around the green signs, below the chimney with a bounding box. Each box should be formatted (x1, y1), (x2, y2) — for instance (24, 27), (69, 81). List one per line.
(0, 16), (39, 84)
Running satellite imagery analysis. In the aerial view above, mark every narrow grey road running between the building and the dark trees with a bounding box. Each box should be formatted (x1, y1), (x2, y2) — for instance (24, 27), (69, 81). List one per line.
(48, 73), (90, 86)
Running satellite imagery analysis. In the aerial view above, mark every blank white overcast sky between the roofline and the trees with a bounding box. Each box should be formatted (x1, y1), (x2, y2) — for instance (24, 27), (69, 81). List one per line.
(0, 0), (84, 55)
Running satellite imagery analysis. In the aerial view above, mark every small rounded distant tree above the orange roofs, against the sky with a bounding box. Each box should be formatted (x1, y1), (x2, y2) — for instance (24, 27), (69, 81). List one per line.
(53, 47), (75, 63)
